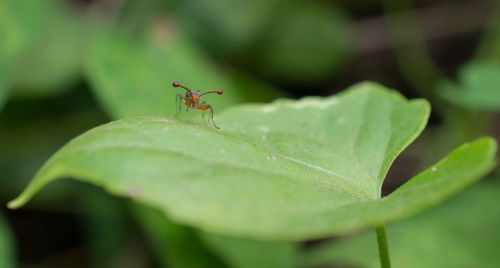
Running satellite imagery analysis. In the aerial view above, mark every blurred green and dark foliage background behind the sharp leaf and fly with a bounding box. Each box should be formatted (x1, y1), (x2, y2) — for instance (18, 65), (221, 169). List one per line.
(0, 0), (500, 267)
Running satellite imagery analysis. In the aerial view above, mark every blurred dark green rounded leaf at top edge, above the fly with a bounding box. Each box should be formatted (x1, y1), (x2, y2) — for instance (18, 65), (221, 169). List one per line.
(176, 0), (290, 56)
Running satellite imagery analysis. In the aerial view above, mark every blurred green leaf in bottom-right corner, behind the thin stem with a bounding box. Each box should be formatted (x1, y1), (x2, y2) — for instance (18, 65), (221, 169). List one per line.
(306, 178), (500, 268)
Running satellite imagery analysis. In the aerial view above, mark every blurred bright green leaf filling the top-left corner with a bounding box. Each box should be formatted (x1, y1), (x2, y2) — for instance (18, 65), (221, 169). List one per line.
(0, 0), (100, 97)
